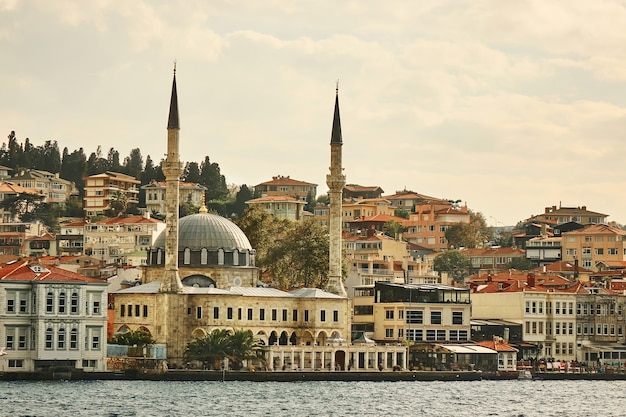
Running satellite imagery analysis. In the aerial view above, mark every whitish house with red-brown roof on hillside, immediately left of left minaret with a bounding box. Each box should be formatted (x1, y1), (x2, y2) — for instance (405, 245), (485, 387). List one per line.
(83, 213), (165, 265)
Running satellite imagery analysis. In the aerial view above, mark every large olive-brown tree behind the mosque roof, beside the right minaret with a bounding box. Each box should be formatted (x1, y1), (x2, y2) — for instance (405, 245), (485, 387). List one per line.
(265, 218), (330, 290)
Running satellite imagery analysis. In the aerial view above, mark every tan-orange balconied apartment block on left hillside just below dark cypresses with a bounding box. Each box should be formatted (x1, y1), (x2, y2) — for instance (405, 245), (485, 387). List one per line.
(83, 171), (140, 217)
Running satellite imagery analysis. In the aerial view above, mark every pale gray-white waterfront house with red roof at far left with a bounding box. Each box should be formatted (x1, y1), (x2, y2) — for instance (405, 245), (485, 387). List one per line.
(0, 261), (107, 372)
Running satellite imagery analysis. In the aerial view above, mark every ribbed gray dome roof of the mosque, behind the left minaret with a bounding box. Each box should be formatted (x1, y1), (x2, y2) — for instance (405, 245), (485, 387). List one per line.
(154, 213), (252, 251)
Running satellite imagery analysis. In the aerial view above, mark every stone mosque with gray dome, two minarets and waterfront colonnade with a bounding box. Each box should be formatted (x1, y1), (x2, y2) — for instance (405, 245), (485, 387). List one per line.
(113, 70), (407, 371)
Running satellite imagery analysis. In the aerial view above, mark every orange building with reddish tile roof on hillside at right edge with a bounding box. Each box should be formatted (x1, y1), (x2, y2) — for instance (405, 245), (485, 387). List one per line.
(563, 224), (626, 271)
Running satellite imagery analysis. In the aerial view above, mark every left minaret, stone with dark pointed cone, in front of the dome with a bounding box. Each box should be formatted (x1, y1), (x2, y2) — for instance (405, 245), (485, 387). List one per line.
(159, 64), (183, 293)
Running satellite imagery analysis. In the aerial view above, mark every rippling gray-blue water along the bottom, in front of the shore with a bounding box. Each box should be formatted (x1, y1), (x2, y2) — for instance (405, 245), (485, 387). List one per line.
(0, 380), (626, 417)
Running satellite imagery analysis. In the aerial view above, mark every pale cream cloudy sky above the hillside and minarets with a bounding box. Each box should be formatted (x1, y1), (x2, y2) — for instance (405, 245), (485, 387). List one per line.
(0, 0), (626, 226)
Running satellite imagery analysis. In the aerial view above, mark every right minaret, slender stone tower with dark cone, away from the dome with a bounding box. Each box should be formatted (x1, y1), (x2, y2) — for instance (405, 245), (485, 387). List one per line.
(326, 83), (347, 297)
